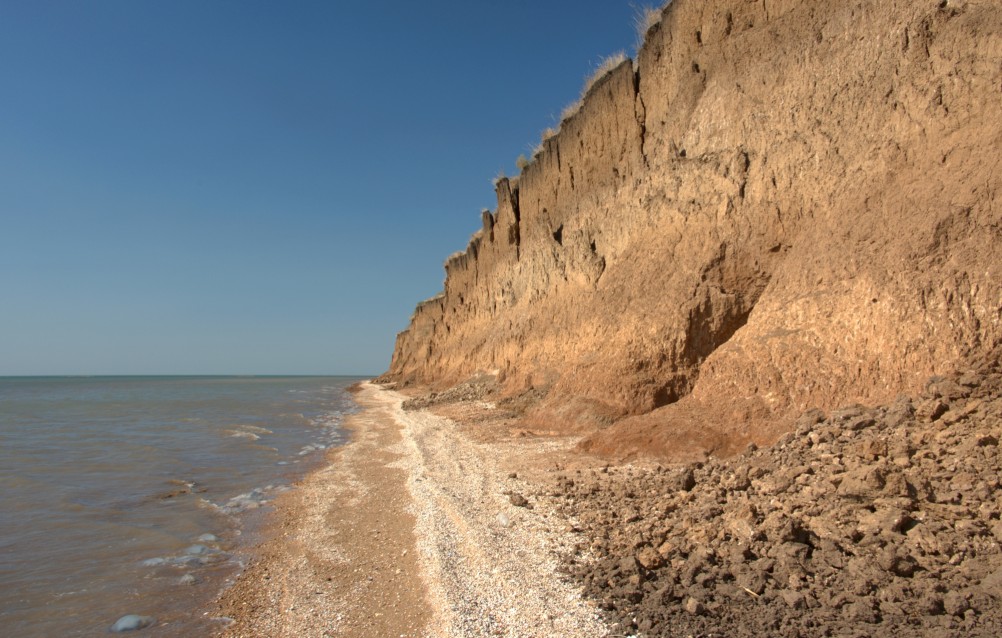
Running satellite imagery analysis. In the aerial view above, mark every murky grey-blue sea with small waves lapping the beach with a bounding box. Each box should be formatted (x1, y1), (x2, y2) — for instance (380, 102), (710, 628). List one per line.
(0, 377), (358, 637)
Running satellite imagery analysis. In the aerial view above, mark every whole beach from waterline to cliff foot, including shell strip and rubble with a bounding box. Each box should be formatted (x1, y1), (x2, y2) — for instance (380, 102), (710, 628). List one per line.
(215, 366), (1002, 638)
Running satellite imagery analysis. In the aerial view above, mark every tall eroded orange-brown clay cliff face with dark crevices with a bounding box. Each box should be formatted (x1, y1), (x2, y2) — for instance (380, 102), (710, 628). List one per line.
(388, 0), (1002, 457)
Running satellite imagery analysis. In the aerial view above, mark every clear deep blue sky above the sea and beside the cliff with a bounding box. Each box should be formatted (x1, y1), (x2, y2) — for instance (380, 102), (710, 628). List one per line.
(0, 0), (639, 375)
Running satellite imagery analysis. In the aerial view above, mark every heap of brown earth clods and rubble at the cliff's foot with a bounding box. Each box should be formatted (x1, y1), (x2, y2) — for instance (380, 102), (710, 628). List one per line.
(549, 367), (1002, 636)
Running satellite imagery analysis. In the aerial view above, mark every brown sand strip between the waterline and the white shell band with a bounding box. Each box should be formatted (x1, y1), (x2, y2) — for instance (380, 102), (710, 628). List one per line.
(216, 387), (431, 638)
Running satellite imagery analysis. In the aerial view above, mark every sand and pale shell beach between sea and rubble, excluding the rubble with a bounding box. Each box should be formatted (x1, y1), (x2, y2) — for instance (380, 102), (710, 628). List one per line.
(214, 384), (607, 638)
